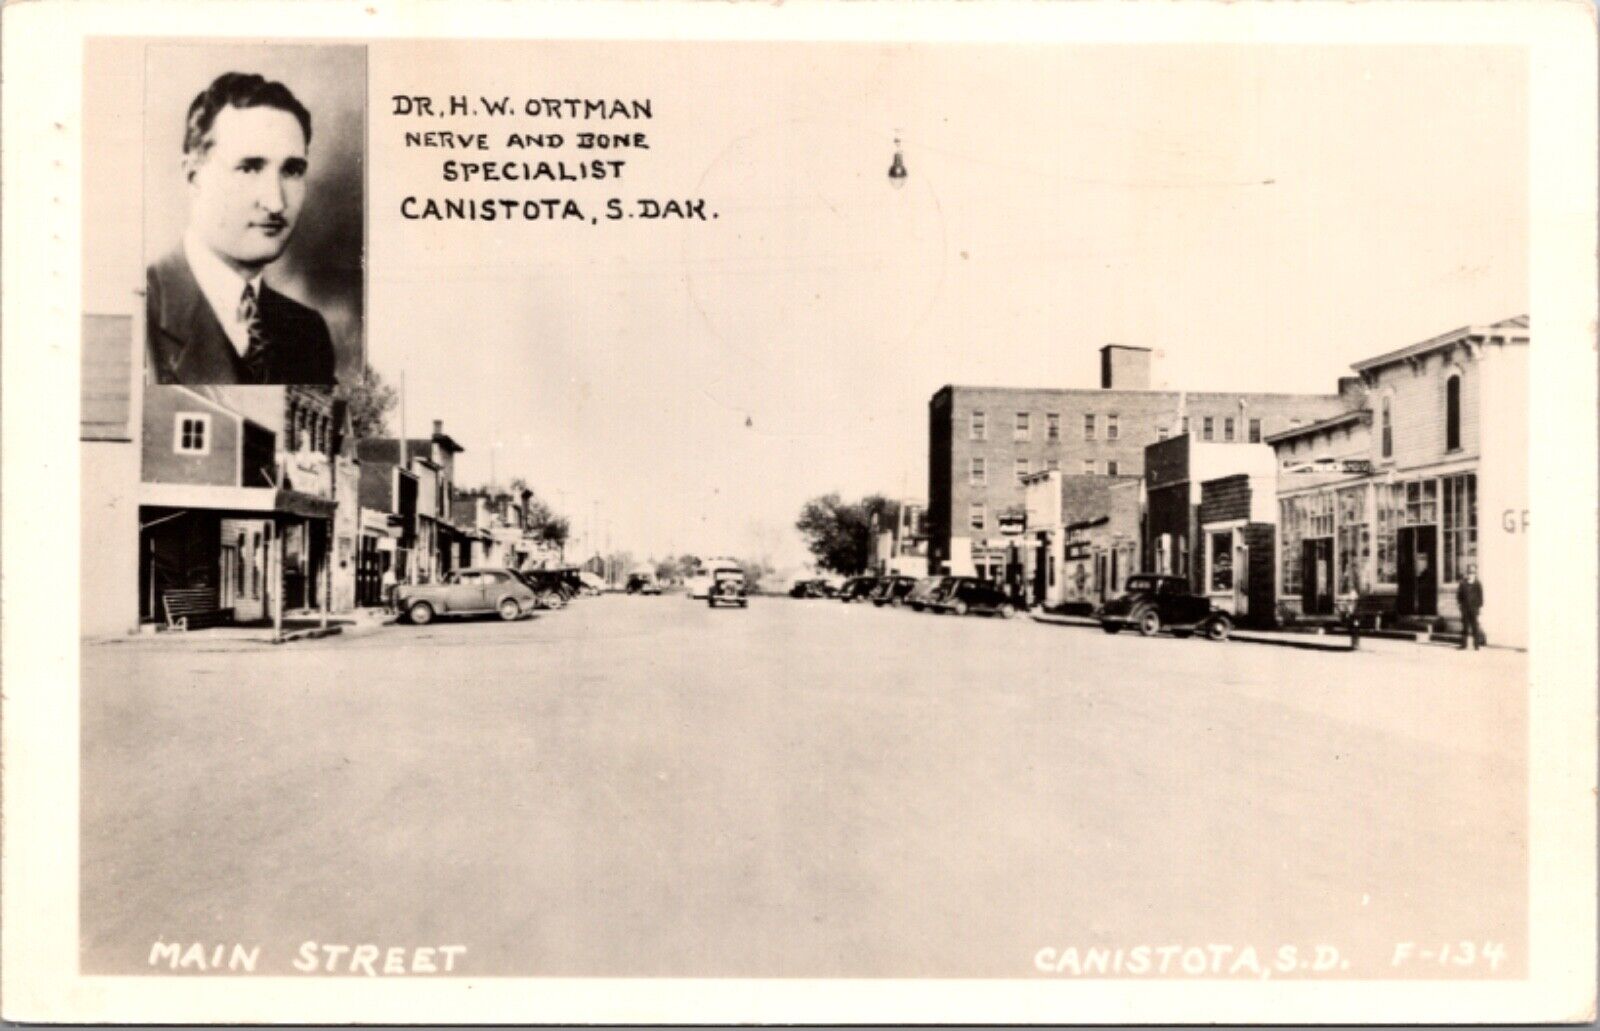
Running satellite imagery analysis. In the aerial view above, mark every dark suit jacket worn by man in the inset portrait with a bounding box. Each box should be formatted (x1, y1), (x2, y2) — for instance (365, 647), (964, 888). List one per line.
(144, 248), (334, 386)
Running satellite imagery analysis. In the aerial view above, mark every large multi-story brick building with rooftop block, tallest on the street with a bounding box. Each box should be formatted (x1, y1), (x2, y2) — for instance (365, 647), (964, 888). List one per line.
(928, 344), (1354, 580)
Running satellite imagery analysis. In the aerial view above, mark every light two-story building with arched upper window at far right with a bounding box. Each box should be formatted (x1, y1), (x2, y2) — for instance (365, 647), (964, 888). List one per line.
(1269, 315), (1528, 645)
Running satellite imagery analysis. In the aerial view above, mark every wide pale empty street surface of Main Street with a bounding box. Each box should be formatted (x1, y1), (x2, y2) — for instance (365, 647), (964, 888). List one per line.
(80, 594), (1528, 977)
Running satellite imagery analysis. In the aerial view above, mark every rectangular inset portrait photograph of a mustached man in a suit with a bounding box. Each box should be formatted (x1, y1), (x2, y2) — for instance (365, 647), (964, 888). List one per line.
(144, 45), (366, 386)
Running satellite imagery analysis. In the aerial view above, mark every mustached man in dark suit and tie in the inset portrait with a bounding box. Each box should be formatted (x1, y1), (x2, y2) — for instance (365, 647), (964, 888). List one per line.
(146, 72), (334, 386)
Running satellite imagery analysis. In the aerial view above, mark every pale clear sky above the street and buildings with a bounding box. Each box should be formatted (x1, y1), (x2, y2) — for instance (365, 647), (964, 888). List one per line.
(366, 42), (1528, 567)
